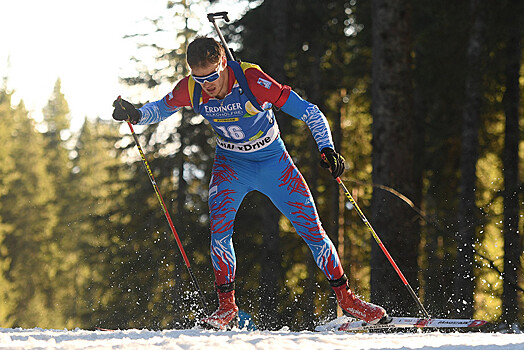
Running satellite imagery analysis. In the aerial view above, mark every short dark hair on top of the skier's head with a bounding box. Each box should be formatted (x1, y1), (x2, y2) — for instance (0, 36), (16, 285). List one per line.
(186, 36), (225, 67)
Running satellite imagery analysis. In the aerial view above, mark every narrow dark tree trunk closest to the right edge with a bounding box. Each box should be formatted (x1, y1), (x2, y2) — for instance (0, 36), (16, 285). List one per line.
(502, 1), (524, 325)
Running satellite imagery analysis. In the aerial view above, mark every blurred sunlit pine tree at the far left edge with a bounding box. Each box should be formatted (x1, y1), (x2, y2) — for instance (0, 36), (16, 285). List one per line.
(0, 92), (58, 327)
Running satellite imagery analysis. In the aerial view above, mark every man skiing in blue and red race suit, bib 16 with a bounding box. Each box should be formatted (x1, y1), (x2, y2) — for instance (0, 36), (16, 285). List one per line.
(113, 37), (387, 329)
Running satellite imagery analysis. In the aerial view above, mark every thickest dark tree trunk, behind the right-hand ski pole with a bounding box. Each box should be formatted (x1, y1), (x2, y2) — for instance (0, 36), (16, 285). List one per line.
(371, 0), (420, 314)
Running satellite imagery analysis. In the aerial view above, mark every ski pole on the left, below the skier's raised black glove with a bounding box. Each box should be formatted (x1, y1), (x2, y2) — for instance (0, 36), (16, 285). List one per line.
(118, 96), (209, 314)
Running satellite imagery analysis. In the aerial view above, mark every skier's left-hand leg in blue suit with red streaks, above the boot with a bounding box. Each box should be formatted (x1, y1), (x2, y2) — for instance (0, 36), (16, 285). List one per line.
(208, 152), (250, 286)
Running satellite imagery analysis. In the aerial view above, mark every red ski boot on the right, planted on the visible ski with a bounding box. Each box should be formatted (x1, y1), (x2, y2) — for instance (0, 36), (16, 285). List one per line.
(329, 275), (387, 324)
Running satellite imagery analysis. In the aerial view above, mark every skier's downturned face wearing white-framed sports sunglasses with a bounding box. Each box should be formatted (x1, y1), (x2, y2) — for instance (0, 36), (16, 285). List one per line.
(191, 56), (228, 98)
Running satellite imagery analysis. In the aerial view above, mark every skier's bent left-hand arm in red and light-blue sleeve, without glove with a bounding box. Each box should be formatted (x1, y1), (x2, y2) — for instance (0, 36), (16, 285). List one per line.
(138, 77), (191, 125)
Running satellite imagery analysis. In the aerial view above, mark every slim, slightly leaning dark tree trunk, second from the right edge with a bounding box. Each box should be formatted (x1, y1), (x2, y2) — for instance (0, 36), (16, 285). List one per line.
(453, 0), (484, 317)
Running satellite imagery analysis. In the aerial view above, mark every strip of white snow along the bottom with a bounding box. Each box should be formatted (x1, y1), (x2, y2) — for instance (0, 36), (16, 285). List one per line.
(0, 328), (524, 350)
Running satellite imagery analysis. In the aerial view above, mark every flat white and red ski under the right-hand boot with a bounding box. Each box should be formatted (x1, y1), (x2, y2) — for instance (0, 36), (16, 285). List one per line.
(316, 316), (487, 332)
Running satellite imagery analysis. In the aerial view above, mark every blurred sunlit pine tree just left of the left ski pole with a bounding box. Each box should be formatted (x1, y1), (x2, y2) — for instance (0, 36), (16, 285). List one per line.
(68, 119), (132, 328)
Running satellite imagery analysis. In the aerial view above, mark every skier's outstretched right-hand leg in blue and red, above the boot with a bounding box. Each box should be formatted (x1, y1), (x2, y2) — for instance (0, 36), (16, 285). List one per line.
(259, 149), (344, 280)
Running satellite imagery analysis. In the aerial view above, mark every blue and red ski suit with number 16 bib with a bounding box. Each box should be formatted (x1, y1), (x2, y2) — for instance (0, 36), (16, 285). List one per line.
(138, 63), (344, 285)
